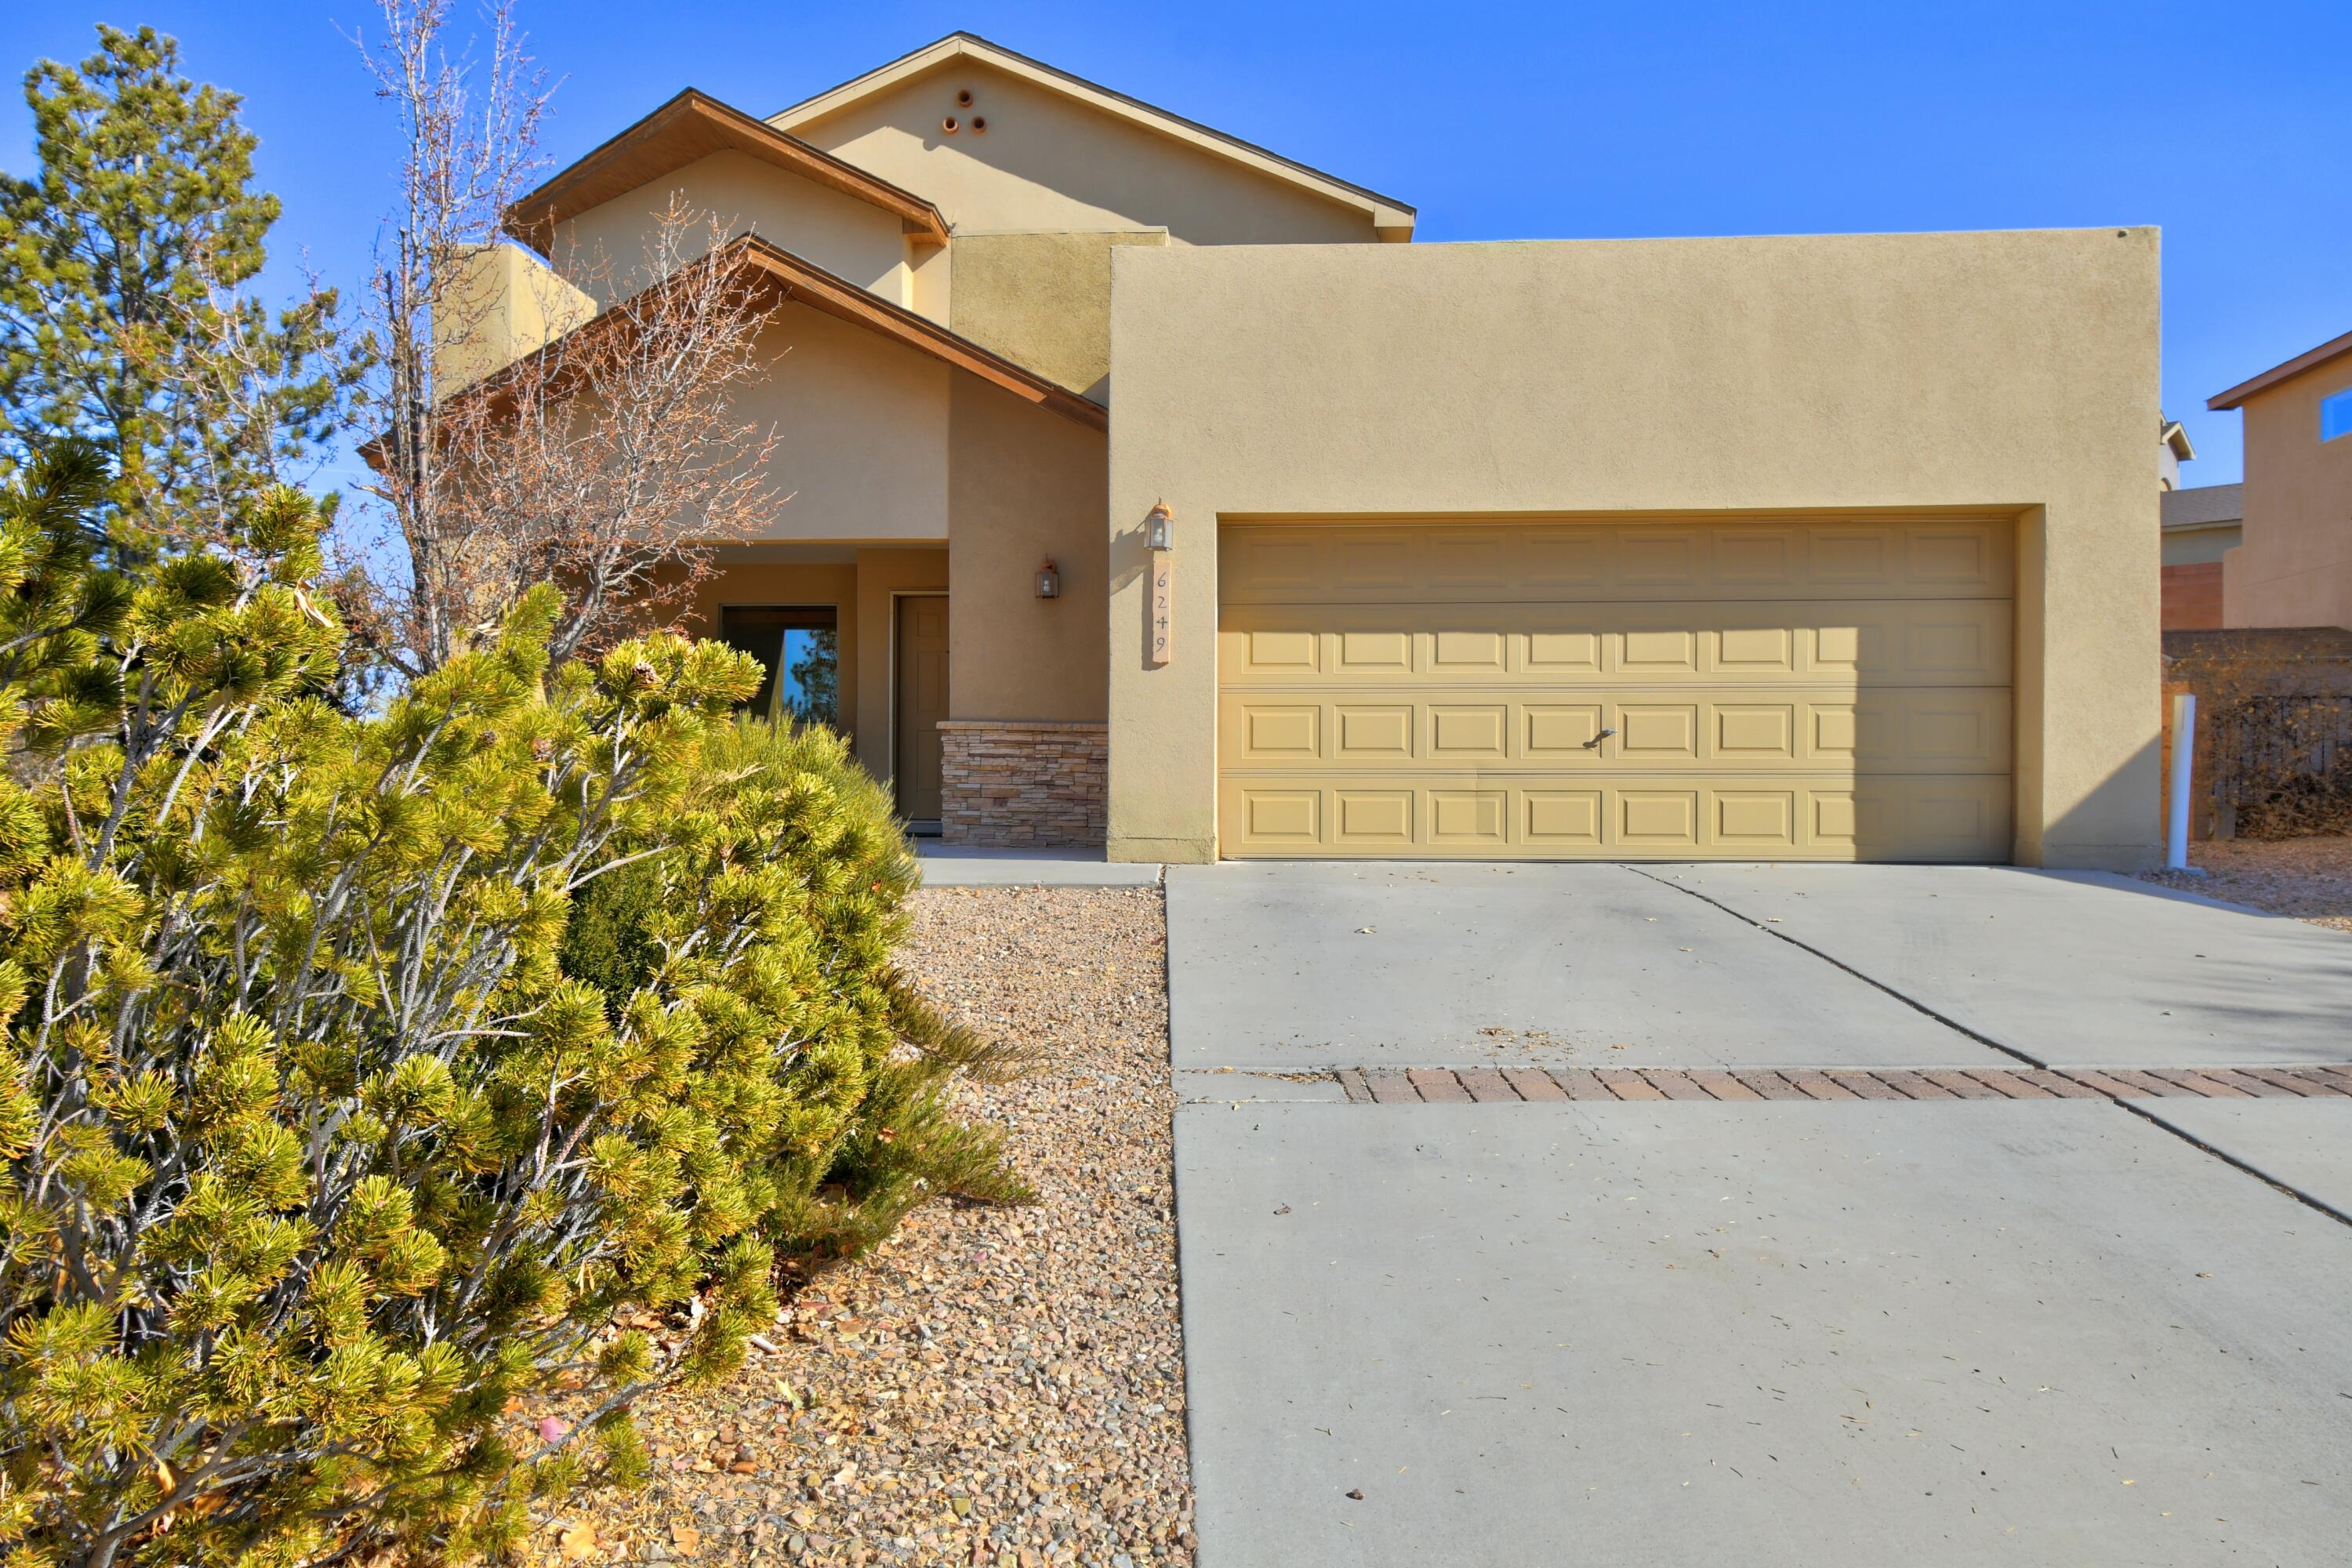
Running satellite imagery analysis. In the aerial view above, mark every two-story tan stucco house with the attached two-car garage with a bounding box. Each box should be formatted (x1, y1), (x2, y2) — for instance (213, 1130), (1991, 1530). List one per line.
(463, 35), (2159, 867)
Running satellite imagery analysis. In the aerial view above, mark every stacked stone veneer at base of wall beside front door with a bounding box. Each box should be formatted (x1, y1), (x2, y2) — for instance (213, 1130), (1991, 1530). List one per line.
(938, 720), (1110, 848)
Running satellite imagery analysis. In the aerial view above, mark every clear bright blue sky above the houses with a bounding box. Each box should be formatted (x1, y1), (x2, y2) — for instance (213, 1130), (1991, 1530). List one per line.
(0, 0), (2352, 485)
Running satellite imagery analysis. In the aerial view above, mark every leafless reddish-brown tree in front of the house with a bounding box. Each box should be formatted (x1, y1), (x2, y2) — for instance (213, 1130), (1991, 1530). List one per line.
(336, 0), (776, 677)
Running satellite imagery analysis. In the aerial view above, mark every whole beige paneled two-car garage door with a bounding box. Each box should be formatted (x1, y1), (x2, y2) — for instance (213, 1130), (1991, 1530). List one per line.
(1216, 520), (2016, 860)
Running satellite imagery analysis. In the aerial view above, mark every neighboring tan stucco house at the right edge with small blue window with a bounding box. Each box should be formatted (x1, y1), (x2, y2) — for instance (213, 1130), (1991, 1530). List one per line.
(2206, 332), (2352, 628)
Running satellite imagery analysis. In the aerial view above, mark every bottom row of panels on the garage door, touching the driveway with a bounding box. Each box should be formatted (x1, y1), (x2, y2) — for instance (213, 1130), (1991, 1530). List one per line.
(1218, 774), (2011, 862)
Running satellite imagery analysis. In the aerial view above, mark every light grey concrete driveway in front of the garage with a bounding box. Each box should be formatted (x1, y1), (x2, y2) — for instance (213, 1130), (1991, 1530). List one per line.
(1169, 865), (2352, 1568)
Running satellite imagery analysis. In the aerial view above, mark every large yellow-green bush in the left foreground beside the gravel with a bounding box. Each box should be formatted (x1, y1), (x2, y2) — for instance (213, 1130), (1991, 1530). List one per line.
(0, 449), (1018, 1566)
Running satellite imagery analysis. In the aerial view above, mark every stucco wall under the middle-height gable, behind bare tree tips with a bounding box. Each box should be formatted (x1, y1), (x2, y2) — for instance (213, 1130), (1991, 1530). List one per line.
(548, 151), (913, 306)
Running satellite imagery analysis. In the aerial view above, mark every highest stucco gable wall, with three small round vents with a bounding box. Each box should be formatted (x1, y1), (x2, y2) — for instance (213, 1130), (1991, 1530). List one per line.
(793, 59), (1374, 245)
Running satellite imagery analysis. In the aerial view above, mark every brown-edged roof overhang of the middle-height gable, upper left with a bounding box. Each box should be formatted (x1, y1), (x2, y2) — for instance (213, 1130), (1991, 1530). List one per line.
(506, 87), (948, 256)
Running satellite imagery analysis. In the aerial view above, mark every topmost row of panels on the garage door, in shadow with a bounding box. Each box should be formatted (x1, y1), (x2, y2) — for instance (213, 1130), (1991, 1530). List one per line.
(1218, 520), (2016, 604)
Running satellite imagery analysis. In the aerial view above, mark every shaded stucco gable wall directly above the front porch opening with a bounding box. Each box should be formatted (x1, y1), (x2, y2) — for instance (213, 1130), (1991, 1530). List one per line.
(739, 306), (960, 543)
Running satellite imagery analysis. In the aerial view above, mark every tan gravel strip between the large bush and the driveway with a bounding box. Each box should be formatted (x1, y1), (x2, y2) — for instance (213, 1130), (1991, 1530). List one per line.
(534, 888), (1192, 1568)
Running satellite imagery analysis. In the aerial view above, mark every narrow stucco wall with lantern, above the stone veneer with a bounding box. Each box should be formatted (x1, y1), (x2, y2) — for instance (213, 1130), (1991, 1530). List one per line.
(948, 376), (1108, 722)
